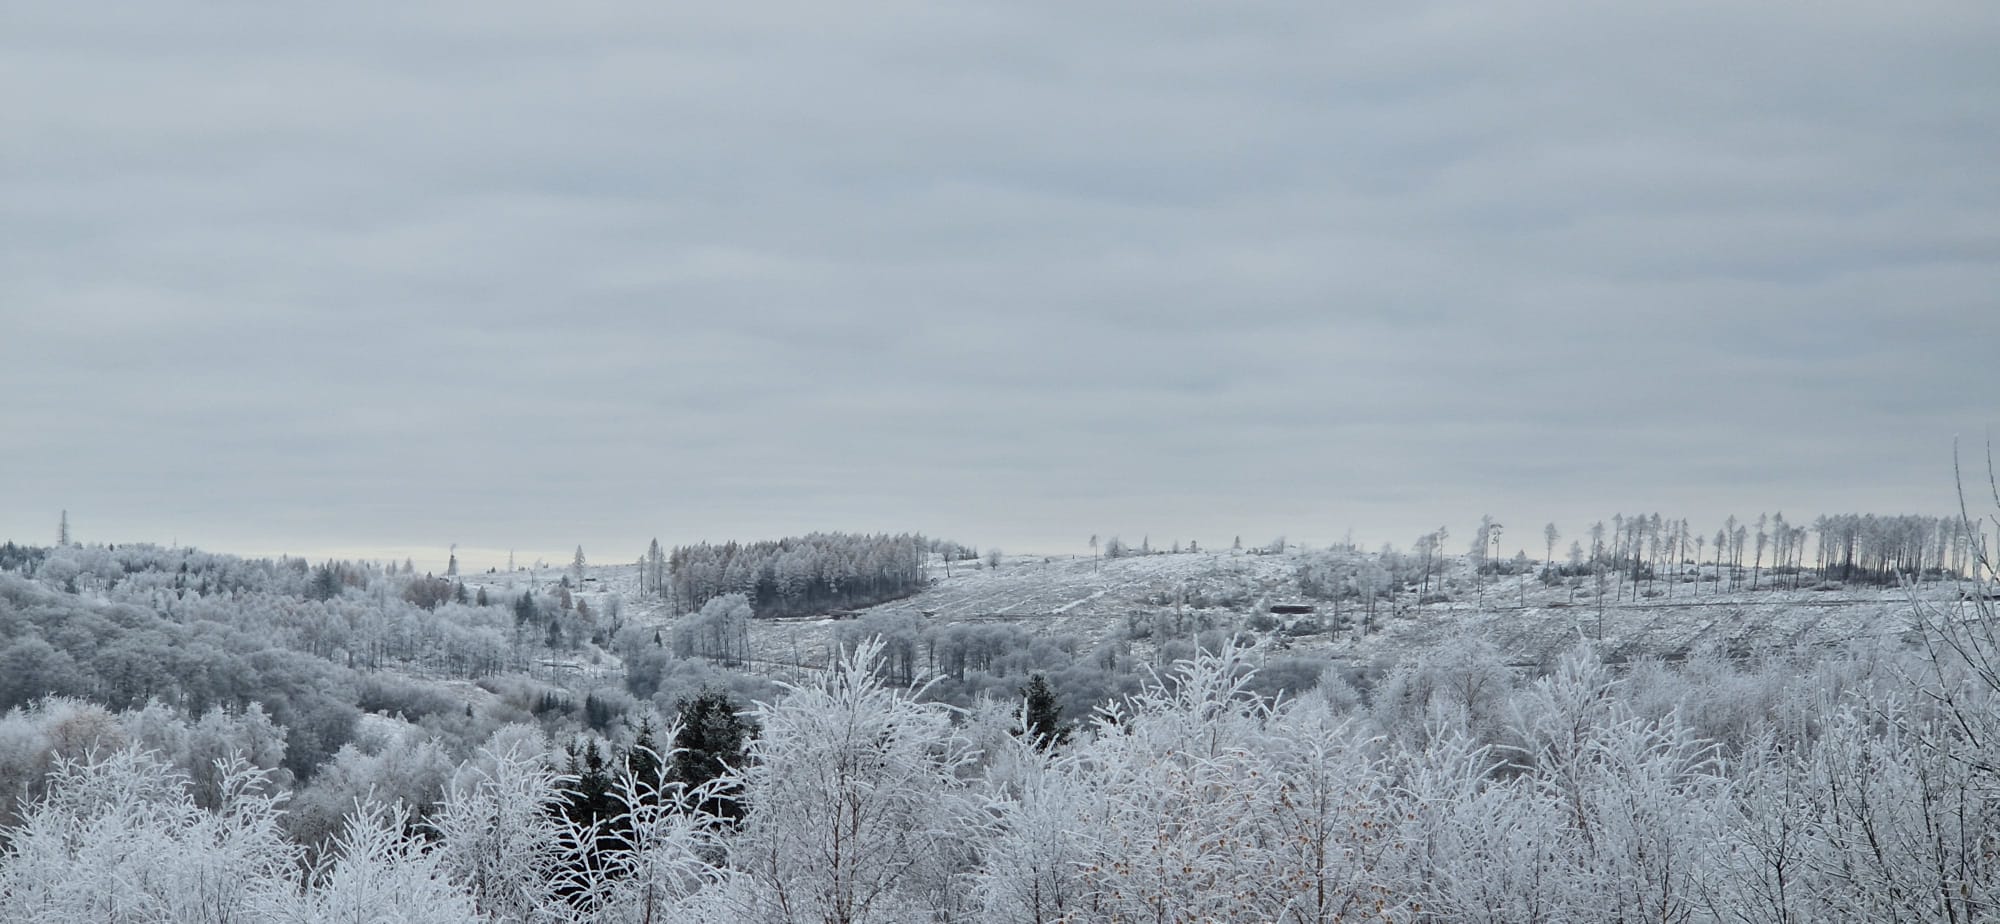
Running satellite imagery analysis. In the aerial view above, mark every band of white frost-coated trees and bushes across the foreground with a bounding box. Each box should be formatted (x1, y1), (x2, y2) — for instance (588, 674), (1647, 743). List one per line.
(0, 642), (2000, 924)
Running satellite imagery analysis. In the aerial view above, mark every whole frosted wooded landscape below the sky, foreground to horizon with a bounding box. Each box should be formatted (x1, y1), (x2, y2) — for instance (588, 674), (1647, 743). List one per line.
(0, 514), (2000, 922)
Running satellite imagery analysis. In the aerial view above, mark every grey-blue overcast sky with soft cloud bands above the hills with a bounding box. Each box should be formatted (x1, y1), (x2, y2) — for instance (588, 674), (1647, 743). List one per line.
(0, 0), (2000, 566)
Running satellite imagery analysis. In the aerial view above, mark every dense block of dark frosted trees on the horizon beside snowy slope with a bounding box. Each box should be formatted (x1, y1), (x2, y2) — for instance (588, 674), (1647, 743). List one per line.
(666, 532), (928, 616)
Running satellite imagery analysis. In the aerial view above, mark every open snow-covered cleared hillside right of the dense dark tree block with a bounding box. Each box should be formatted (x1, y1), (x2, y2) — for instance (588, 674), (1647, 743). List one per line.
(874, 552), (1960, 666)
